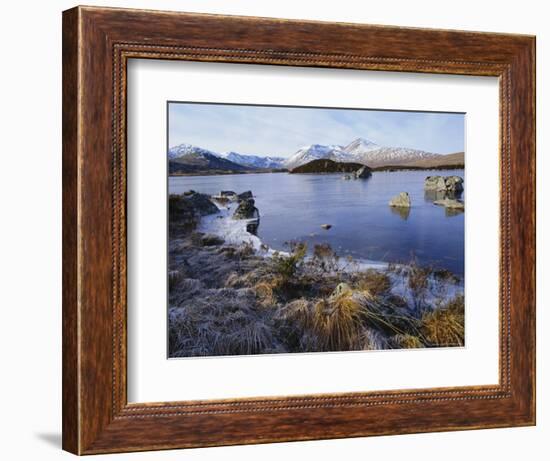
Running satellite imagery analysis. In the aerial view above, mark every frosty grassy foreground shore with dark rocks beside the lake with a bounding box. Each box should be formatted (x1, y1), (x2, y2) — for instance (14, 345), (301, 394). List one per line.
(168, 191), (464, 357)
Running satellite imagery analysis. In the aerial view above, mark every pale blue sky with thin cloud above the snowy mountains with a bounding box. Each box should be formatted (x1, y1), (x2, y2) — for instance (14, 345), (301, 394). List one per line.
(168, 103), (464, 157)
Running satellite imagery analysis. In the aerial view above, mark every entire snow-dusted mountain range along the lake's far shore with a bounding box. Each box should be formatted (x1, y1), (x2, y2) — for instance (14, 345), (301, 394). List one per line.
(168, 138), (464, 174)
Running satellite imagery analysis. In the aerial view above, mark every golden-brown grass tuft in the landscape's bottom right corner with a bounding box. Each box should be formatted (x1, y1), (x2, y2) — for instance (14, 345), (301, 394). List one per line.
(422, 295), (465, 347)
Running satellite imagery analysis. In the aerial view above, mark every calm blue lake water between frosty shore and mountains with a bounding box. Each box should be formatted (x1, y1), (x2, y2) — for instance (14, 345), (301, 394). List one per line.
(169, 170), (464, 276)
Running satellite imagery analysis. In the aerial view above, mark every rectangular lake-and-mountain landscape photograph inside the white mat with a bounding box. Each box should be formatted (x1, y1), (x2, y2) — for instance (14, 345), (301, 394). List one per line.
(167, 101), (465, 358)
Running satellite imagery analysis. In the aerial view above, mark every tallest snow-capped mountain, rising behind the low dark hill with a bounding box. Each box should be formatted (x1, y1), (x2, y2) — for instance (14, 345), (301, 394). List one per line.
(283, 138), (438, 169)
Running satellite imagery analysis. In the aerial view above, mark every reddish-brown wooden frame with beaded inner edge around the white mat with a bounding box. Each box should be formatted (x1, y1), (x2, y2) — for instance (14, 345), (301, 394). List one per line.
(63, 7), (535, 454)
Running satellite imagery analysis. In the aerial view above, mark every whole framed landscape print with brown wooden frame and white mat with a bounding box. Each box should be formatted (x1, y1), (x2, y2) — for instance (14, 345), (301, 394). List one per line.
(63, 7), (535, 454)
